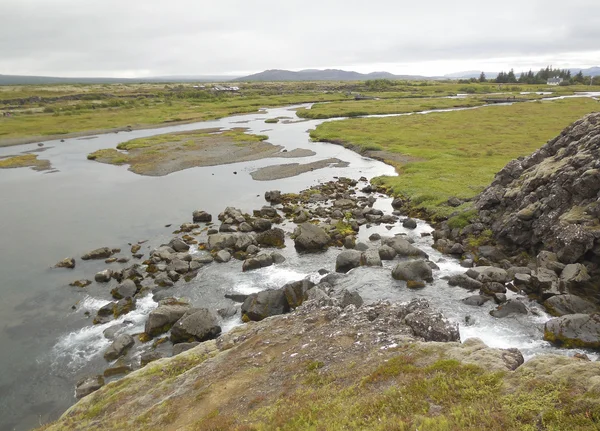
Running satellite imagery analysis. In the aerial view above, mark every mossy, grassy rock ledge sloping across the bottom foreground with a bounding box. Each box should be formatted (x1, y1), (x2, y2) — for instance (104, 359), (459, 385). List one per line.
(40, 301), (600, 431)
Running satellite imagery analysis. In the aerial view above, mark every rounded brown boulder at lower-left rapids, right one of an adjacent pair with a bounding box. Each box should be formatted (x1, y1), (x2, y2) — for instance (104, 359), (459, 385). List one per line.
(171, 308), (221, 344)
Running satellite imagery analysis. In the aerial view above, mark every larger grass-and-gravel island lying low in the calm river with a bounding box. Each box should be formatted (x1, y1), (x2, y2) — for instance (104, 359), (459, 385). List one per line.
(88, 128), (315, 176)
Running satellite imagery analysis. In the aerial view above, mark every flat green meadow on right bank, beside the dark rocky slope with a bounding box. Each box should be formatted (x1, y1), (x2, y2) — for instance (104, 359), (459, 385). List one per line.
(311, 98), (600, 219)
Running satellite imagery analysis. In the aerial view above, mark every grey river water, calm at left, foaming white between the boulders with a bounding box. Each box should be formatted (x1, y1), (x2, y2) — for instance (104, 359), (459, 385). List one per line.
(0, 102), (592, 431)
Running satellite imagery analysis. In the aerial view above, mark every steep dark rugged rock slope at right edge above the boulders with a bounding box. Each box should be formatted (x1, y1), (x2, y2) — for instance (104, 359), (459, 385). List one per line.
(475, 113), (600, 264)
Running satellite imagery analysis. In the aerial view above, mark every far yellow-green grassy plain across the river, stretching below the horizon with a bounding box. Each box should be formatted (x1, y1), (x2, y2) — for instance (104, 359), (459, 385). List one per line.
(0, 80), (590, 145)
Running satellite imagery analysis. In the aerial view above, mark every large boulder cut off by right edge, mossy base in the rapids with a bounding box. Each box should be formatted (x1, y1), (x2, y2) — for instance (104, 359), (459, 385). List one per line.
(544, 314), (600, 349)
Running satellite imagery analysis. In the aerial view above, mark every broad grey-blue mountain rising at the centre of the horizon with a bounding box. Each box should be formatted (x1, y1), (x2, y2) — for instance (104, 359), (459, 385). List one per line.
(234, 69), (427, 81)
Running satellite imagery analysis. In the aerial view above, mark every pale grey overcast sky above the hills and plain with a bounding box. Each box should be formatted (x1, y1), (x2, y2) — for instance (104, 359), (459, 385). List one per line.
(0, 0), (600, 77)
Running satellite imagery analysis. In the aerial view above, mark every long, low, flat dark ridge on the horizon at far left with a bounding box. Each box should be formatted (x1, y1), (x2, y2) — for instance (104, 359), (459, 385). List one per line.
(0, 75), (239, 85)
